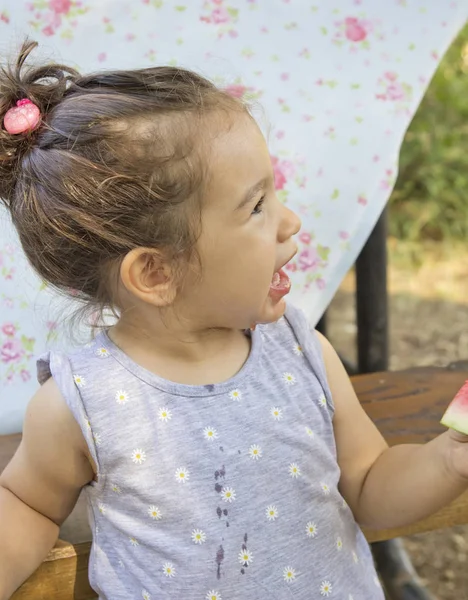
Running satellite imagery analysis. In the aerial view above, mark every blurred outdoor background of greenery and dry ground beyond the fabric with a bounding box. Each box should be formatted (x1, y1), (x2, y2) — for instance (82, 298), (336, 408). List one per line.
(327, 21), (468, 600)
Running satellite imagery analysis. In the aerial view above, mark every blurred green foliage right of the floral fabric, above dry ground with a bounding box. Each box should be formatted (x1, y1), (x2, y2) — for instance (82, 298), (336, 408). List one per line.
(390, 26), (468, 241)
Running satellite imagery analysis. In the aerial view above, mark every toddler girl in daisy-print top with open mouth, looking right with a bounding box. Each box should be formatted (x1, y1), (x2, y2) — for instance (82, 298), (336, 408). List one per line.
(0, 42), (468, 600)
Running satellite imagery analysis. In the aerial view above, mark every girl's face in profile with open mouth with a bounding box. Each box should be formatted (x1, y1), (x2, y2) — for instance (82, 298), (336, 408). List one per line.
(179, 115), (301, 329)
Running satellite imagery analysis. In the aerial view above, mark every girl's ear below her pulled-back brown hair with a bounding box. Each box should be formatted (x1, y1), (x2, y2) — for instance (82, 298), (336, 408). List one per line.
(120, 248), (177, 307)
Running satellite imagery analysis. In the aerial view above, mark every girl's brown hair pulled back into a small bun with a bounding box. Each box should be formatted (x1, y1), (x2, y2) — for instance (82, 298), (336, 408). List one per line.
(0, 40), (244, 309)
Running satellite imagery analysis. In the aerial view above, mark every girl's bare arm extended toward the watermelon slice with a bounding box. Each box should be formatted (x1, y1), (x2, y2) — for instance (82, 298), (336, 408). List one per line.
(318, 334), (468, 529)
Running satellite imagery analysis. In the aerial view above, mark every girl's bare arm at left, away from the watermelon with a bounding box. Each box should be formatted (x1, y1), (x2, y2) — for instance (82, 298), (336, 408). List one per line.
(0, 379), (94, 600)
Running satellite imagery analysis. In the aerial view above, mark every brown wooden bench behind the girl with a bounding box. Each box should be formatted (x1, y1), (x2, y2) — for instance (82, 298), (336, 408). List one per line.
(0, 362), (468, 600)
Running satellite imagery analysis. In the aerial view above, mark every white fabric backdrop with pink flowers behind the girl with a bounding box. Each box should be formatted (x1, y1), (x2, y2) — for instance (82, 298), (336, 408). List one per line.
(0, 0), (468, 434)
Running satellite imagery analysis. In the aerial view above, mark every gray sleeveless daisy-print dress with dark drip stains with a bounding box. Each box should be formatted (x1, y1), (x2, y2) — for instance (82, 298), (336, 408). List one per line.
(38, 306), (384, 600)
